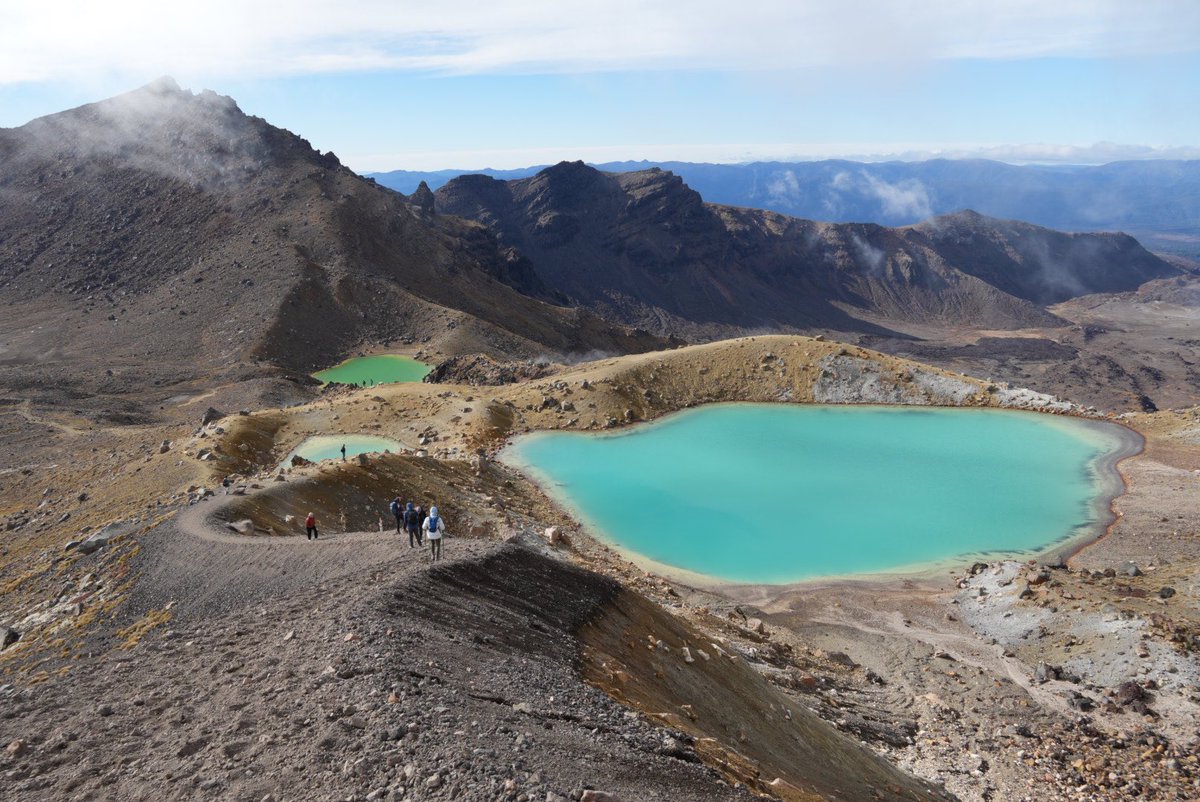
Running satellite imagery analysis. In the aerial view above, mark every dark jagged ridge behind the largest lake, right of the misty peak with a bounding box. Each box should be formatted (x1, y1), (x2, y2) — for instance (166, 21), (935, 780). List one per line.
(436, 162), (1178, 334)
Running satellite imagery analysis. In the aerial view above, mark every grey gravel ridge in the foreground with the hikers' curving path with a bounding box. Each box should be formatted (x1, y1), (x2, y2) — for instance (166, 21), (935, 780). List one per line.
(0, 498), (752, 802)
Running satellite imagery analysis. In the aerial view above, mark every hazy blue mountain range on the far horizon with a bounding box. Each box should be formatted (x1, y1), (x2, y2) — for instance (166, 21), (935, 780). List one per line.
(370, 160), (1200, 258)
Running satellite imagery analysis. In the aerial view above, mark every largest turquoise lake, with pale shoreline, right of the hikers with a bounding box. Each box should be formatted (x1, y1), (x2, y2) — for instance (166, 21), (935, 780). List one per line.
(503, 405), (1136, 583)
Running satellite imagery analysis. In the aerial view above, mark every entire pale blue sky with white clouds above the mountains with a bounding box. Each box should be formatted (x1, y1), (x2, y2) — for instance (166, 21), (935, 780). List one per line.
(0, 0), (1200, 170)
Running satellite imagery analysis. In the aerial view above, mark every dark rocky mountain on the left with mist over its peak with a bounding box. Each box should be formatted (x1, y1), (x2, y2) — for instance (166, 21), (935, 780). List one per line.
(0, 79), (653, 418)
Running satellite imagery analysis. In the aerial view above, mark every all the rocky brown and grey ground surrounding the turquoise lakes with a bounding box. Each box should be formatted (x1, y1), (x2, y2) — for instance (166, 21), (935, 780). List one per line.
(0, 337), (1200, 802)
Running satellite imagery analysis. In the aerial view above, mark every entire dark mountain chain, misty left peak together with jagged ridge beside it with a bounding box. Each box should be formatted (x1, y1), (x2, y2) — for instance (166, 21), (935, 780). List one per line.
(0, 80), (1180, 421)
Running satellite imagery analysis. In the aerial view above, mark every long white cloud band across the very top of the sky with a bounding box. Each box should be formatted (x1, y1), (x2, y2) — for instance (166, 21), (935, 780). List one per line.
(0, 0), (1200, 83)
